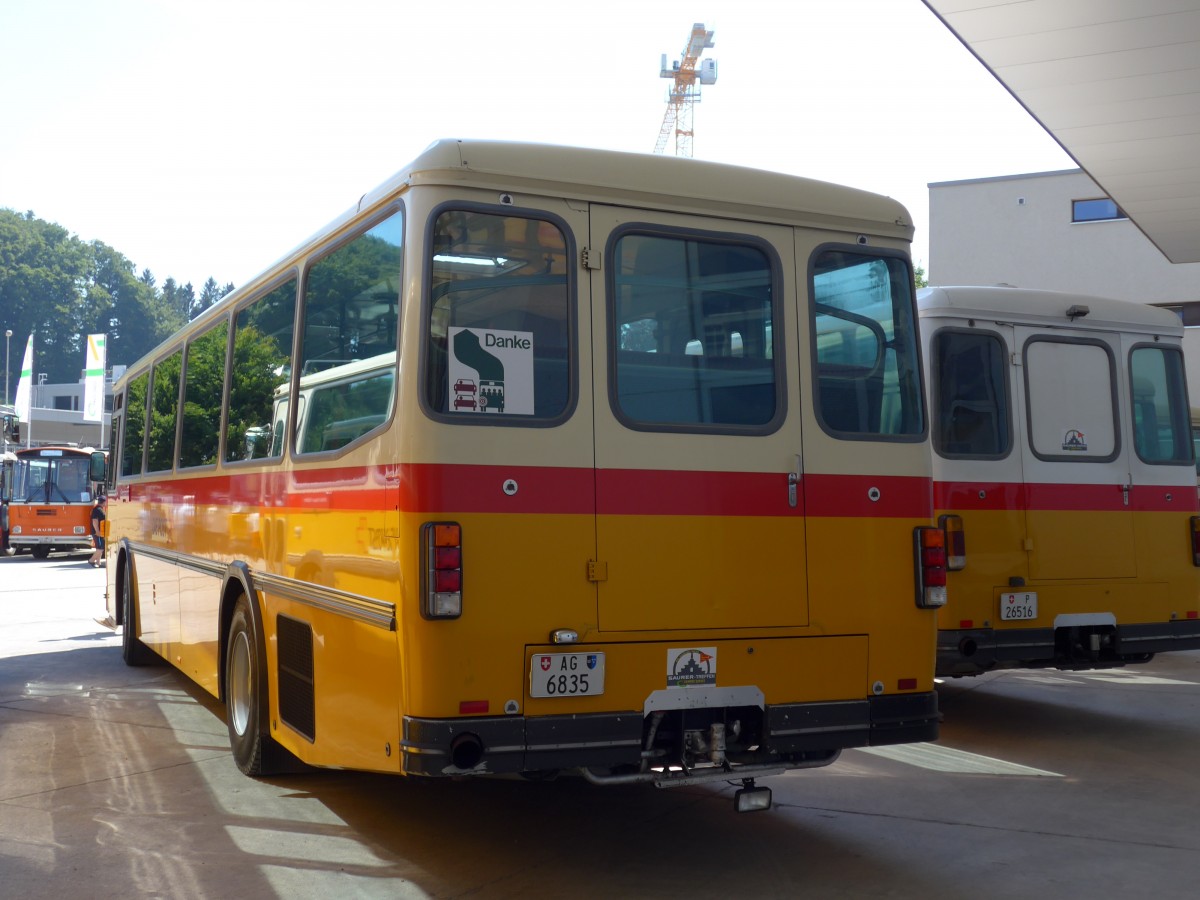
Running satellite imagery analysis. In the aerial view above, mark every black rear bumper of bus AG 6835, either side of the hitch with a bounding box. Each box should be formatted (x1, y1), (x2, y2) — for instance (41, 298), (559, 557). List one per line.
(401, 691), (937, 776)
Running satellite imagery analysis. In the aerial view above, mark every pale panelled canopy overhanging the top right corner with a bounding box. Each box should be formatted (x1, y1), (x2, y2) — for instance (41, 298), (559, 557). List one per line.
(923, 0), (1200, 263)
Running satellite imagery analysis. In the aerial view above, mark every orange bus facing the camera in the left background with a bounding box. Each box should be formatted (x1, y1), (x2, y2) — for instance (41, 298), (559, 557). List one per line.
(7, 446), (104, 559)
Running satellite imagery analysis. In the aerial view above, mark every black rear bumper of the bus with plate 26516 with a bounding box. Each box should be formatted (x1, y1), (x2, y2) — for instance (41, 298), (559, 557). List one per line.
(937, 619), (1200, 677)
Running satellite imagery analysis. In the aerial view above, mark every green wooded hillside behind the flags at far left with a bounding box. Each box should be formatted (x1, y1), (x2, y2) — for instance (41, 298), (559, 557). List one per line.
(0, 209), (226, 395)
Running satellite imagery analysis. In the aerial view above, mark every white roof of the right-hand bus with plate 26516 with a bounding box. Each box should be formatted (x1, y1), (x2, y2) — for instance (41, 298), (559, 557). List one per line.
(917, 286), (1183, 336)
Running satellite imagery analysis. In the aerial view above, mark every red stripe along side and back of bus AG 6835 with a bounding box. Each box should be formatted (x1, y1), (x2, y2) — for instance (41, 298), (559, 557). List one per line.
(119, 463), (932, 518)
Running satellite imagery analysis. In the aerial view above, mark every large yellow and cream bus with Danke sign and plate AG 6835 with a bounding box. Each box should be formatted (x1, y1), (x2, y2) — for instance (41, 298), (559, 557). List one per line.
(108, 140), (944, 809)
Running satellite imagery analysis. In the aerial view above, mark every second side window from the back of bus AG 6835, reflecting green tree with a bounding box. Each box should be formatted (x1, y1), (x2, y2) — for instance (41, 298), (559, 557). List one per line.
(224, 278), (296, 462)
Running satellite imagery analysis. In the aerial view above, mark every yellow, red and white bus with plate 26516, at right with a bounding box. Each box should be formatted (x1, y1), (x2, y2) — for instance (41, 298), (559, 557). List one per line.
(918, 287), (1200, 676)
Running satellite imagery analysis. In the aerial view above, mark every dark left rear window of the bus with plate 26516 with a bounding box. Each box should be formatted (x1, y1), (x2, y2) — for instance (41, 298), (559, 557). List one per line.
(929, 331), (1010, 457)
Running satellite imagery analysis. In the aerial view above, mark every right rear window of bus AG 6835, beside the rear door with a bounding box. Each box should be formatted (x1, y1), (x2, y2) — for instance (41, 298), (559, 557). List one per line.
(811, 250), (925, 439)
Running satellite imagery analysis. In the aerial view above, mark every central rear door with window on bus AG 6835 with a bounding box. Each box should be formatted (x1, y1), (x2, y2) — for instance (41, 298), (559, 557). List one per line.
(592, 206), (809, 632)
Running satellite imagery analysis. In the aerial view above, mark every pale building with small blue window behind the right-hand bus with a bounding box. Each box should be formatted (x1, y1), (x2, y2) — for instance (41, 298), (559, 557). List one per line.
(928, 169), (1200, 406)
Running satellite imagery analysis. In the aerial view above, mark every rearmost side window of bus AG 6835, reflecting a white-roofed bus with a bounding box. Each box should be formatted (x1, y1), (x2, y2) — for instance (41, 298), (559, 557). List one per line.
(295, 212), (404, 454)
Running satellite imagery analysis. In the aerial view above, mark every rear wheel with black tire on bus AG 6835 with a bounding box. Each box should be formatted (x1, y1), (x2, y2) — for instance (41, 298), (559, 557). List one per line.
(224, 594), (286, 775)
